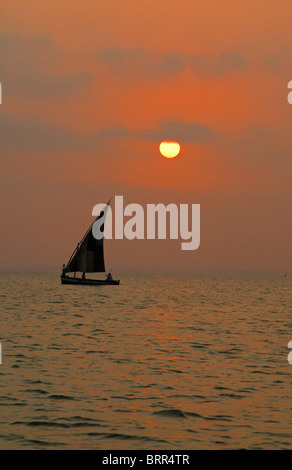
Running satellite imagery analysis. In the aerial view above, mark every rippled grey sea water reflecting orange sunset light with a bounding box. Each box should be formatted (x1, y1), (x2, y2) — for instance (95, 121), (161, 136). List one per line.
(0, 273), (292, 450)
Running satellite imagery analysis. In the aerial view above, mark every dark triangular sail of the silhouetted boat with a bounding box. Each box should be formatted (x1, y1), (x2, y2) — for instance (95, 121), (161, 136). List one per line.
(65, 201), (106, 273)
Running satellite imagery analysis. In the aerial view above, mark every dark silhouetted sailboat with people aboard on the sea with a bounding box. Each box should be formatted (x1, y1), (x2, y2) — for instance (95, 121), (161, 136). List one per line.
(61, 201), (120, 286)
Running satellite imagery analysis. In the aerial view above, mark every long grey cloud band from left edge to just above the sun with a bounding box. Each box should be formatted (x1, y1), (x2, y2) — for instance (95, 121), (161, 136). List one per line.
(0, 114), (217, 151)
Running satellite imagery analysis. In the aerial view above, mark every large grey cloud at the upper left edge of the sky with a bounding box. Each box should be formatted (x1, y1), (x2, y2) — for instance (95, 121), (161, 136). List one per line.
(0, 34), (94, 98)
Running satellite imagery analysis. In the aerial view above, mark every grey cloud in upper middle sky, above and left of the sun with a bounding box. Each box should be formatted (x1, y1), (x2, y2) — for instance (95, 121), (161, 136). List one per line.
(94, 47), (187, 79)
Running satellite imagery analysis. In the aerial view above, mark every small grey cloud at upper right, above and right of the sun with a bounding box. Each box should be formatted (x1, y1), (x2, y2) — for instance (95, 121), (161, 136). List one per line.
(190, 50), (250, 77)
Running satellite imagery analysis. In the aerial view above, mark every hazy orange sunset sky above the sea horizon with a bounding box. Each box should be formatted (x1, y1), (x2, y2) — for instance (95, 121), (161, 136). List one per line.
(0, 0), (292, 271)
